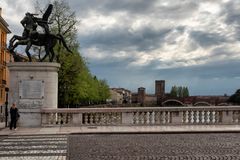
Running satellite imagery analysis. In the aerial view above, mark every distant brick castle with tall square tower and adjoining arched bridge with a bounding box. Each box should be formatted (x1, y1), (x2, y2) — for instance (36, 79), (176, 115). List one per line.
(132, 80), (229, 106)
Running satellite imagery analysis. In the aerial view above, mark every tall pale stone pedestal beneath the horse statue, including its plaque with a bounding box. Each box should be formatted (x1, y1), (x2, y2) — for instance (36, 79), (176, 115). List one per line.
(7, 62), (60, 127)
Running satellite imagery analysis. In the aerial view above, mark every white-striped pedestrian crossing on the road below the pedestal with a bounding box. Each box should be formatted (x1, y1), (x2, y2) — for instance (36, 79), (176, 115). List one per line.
(0, 135), (67, 160)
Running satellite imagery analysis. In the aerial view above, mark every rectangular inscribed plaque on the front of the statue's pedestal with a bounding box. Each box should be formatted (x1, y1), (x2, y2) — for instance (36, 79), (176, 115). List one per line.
(19, 80), (44, 99)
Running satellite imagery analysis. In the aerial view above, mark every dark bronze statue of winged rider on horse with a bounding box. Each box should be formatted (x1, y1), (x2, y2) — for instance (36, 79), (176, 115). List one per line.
(8, 4), (72, 62)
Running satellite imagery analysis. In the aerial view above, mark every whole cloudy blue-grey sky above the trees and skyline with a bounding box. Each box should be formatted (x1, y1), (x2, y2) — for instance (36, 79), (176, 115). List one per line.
(0, 0), (240, 95)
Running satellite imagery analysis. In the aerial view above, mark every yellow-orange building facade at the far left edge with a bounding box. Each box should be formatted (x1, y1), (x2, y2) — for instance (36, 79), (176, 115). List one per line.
(0, 8), (11, 106)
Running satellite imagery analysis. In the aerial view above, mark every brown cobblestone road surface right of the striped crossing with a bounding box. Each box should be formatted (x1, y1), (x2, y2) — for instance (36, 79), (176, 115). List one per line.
(67, 133), (240, 160)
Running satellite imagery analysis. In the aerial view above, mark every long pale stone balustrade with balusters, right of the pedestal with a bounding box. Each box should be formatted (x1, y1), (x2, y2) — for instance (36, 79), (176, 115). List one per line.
(41, 106), (240, 126)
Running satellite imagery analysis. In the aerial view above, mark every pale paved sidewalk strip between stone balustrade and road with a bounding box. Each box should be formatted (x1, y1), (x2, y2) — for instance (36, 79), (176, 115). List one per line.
(0, 125), (240, 136)
